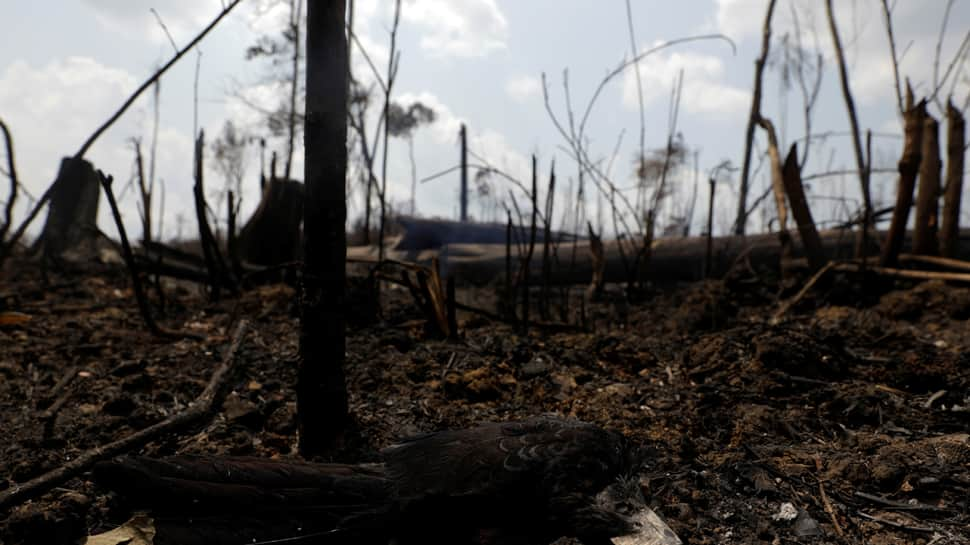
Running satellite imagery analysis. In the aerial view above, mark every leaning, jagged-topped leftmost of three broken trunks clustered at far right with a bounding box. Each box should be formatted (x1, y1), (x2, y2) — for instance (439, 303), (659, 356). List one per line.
(879, 88), (926, 267)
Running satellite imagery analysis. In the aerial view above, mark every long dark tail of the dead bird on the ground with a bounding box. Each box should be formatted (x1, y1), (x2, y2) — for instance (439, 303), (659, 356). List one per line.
(94, 456), (392, 545)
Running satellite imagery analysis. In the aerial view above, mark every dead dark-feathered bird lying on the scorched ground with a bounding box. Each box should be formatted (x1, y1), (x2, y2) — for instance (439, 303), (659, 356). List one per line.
(94, 416), (679, 545)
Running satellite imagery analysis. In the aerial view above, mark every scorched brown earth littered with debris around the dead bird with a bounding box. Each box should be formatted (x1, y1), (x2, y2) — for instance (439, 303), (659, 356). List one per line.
(0, 261), (970, 545)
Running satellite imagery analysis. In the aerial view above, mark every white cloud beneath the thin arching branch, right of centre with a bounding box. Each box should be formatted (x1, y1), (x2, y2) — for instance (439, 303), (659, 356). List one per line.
(623, 49), (751, 118)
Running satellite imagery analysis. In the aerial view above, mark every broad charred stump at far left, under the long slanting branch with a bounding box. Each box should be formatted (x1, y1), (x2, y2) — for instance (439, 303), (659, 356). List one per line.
(34, 157), (101, 260)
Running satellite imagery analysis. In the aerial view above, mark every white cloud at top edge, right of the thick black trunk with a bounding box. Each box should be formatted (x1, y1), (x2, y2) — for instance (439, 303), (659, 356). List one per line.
(401, 0), (508, 58)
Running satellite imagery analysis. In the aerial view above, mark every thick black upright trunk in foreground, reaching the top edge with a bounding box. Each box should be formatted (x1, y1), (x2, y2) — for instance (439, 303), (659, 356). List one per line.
(296, 0), (348, 457)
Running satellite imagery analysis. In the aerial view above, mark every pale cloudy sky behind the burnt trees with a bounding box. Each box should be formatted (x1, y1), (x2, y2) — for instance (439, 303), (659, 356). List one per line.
(0, 0), (970, 242)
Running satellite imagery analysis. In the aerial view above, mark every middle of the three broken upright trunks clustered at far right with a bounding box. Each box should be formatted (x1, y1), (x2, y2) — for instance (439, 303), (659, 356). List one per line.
(913, 114), (940, 255)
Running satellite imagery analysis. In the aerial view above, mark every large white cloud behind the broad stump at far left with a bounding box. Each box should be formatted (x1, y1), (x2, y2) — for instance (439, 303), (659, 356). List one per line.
(0, 57), (206, 237)
